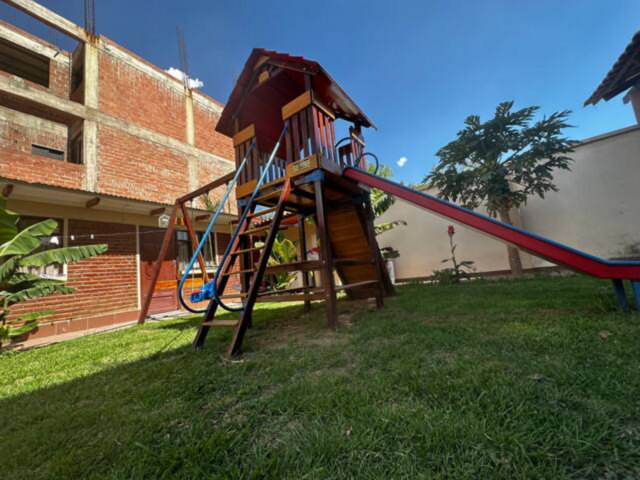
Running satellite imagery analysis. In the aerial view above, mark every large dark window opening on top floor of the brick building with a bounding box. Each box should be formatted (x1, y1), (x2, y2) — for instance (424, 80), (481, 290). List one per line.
(0, 38), (50, 88)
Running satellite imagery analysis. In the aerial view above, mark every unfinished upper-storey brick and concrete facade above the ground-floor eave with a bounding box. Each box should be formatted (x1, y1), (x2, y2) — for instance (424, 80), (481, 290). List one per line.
(0, 22), (234, 205)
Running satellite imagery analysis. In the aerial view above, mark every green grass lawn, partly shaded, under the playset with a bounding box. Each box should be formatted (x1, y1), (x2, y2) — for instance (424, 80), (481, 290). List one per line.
(0, 277), (640, 480)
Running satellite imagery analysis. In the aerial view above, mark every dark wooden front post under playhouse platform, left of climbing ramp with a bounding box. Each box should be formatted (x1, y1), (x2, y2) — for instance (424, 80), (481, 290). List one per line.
(314, 180), (338, 329)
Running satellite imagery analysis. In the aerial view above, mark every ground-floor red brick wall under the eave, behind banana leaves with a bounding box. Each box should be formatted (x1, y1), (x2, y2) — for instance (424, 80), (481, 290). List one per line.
(12, 220), (138, 333)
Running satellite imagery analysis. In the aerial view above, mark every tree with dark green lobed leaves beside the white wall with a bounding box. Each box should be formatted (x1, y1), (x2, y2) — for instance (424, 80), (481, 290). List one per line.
(425, 102), (575, 276)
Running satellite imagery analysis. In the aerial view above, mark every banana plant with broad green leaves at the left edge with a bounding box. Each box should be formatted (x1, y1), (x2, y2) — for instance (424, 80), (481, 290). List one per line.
(0, 196), (107, 346)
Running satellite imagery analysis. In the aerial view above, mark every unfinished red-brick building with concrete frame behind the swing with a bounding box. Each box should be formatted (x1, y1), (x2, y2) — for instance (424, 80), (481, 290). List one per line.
(0, 0), (234, 344)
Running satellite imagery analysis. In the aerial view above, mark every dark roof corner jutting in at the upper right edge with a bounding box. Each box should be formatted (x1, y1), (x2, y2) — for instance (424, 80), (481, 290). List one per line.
(584, 32), (640, 106)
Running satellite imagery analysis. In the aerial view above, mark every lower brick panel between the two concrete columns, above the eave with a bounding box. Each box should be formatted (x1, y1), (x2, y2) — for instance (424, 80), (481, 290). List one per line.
(98, 125), (189, 203)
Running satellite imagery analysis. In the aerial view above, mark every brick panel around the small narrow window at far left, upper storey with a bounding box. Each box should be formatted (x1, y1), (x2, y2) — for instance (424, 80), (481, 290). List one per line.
(0, 117), (85, 189)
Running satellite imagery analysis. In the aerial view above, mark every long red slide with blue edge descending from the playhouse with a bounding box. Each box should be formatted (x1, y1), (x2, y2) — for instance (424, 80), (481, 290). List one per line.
(343, 168), (640, 282)
